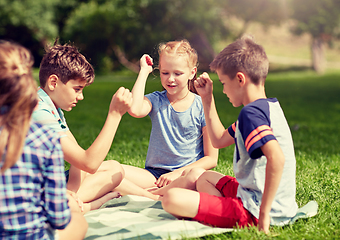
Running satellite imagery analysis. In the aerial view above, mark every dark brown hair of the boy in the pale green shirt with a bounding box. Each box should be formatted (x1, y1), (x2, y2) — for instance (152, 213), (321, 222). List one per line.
(39, 44), (94, 88)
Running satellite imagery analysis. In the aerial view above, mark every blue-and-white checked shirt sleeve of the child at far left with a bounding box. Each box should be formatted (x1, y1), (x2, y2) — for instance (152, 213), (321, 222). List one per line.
(44, 133), (71, 229)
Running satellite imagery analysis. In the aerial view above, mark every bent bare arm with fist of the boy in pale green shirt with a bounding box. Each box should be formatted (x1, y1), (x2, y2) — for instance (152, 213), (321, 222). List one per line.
(61, 87), (132, 173)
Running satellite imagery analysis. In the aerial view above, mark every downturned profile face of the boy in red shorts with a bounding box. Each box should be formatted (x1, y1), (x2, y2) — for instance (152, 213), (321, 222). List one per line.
(216, 69), (242, 107)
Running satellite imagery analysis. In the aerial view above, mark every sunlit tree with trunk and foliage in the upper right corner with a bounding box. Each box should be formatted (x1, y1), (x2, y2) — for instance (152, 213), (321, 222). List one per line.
(291, 0), (340, 73)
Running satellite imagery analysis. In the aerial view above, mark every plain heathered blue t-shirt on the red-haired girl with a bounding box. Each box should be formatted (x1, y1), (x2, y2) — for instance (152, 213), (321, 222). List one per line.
(145, 91), (206, 171)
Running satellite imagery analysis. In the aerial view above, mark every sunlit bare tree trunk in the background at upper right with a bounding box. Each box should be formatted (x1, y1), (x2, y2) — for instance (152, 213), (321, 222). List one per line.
(312, 37), (326, 74)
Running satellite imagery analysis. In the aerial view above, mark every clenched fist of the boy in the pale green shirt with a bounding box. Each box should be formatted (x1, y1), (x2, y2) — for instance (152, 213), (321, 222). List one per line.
(110, 87), (132, 116)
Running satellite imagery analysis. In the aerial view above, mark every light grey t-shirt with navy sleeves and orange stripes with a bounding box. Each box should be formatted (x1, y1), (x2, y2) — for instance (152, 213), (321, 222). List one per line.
(228, 98), (298, 225)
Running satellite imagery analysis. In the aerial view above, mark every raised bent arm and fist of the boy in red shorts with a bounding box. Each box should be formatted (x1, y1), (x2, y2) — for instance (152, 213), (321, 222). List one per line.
(195, 73), (234, 148)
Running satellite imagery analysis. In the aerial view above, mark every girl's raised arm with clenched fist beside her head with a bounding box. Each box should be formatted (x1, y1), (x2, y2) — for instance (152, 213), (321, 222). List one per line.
(128, 54), (152, 118)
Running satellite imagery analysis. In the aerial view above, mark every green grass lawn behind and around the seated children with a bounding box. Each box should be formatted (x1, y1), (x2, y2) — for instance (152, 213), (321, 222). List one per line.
(65, 71), (340, 239)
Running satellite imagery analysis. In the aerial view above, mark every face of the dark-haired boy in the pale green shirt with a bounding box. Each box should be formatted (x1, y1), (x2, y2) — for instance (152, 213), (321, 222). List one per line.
(50, 79), (86, 111)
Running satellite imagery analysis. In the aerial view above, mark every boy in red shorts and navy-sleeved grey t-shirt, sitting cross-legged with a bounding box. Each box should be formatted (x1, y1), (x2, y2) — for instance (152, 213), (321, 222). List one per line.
(162, 37), (298, 233)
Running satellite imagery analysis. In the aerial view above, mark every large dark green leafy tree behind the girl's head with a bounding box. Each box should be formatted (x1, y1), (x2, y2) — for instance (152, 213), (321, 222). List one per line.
(63, 0), (227, 71)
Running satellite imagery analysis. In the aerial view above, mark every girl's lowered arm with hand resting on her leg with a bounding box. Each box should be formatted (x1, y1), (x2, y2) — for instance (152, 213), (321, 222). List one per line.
(156, 127), (218, 187)
